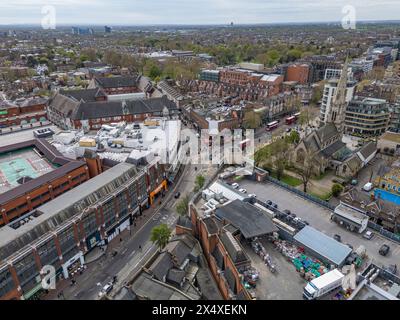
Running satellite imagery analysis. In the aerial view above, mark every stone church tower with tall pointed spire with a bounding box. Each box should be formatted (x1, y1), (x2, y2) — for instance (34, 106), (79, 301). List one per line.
(327, 59), (348, 132)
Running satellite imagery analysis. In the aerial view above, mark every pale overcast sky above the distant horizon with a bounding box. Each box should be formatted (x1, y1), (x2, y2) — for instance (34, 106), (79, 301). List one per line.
(0, 0), (400, 25)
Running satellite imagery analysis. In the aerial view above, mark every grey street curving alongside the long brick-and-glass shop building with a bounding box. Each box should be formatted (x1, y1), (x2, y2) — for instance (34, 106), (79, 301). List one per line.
(42, 165), (217, 300)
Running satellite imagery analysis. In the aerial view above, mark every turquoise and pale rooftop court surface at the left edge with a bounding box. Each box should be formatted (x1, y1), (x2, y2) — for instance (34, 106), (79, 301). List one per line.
(0, 148), (54, 193)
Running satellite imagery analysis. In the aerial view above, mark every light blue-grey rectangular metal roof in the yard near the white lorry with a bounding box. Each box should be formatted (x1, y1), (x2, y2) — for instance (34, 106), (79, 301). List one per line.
(294, 226), (351, 265)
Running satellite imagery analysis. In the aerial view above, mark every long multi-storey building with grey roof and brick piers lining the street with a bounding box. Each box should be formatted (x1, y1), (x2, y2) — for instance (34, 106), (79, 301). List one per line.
(0, 163), (165, 299)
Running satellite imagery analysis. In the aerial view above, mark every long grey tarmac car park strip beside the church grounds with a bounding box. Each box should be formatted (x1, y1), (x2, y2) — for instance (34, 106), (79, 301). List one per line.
(240, 180), (400, 266)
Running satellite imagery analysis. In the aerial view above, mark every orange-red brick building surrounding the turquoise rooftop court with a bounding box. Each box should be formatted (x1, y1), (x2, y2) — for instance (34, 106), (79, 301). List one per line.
(0, 139), (90, 226)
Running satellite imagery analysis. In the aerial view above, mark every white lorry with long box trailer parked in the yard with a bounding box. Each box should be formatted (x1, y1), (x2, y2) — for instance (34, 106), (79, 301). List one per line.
(303, 269), (344, 300)
